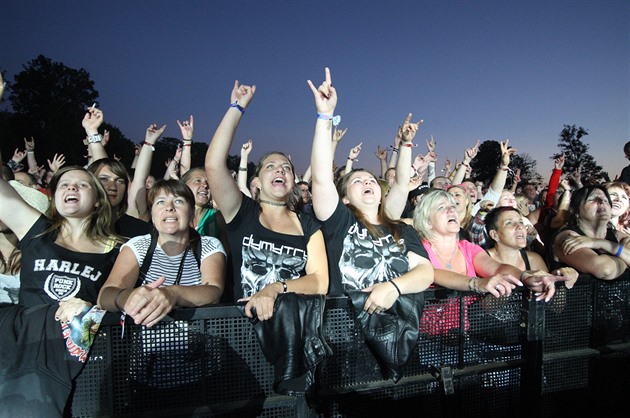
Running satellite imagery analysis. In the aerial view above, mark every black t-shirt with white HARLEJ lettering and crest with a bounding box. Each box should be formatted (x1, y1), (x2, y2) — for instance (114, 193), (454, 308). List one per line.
(18, 215), (118, 307)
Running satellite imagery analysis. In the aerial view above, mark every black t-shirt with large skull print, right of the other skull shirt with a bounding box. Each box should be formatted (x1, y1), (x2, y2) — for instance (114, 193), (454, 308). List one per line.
(322, 200), (429, 295)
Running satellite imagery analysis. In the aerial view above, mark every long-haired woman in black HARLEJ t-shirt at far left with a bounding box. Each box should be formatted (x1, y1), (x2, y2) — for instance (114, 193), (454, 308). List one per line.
(0, 162), (120, 417)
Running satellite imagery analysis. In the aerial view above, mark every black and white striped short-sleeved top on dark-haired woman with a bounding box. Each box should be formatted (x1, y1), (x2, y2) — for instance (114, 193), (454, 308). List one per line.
(121, 235), (225, 286)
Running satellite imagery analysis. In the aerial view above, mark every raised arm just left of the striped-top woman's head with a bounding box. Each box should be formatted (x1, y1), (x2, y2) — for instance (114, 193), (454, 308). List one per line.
(127, 123), (166, 220)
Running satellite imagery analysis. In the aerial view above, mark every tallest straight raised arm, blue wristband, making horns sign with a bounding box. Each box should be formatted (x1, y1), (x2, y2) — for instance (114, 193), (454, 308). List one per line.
(308, 68), (339, 221)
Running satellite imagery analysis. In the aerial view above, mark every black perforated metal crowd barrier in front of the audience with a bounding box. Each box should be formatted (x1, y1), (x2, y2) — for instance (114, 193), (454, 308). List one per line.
(68, 275), (630, 418)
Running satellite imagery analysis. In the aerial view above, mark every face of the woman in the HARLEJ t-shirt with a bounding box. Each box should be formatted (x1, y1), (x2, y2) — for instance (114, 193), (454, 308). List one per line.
(54, 170), (98, 218)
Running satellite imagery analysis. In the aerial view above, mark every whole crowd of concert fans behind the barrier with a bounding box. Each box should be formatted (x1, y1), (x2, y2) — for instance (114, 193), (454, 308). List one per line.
(0, 69), (630, 415)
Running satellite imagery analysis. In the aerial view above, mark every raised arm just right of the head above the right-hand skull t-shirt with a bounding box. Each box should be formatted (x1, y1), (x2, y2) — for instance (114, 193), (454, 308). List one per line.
(385, 113), (423, 219)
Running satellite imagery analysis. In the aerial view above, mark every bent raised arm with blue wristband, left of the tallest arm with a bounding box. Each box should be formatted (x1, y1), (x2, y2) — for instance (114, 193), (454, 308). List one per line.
(205, 80), (256, 223)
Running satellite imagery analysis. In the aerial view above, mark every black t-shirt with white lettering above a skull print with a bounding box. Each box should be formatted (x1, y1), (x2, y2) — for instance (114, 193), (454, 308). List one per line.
(227, 195), (321, 300)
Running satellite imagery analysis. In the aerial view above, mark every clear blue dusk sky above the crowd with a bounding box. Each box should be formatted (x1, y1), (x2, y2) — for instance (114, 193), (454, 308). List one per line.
(0, 0), (630, 180)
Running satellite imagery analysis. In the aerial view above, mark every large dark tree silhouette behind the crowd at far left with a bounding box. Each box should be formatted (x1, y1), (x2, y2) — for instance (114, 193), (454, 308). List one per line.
(0, 55), (133, 171)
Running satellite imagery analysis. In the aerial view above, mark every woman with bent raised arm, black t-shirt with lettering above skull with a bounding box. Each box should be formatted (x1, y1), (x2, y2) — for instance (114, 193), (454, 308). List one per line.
(205, 81), (328, 320)
